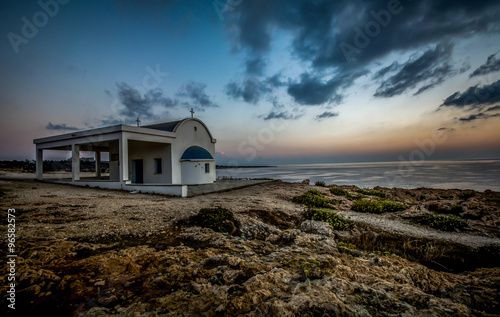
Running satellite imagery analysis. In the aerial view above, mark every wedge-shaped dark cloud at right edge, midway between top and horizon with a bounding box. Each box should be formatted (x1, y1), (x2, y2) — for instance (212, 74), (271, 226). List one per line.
(440, 80), (500, 108)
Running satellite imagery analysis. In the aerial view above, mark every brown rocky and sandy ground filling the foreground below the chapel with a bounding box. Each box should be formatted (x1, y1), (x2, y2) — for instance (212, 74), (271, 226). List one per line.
(0, 175), (500, 316)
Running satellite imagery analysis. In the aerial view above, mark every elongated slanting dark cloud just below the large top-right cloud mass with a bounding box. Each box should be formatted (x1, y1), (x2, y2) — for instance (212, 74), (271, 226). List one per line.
(374, 44), (453, 98)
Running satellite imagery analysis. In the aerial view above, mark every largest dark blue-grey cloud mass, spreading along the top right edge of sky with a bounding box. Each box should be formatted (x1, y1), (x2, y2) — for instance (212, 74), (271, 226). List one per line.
(227, 0), (500, 68)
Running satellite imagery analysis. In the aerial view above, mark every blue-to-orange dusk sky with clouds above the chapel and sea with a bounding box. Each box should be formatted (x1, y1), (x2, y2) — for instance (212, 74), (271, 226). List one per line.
(0, 0), (500, 165)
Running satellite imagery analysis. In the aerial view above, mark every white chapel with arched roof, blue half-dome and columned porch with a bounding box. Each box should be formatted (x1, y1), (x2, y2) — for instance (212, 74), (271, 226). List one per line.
(33, 115), (216, 197)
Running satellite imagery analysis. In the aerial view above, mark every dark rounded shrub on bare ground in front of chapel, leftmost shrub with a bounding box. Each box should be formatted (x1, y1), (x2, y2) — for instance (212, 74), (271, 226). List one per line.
(193, 207), (241, 233)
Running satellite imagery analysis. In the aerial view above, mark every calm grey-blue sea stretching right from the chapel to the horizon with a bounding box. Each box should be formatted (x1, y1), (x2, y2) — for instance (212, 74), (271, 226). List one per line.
(217, 160), (500, 191)
